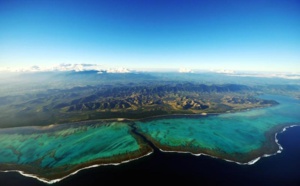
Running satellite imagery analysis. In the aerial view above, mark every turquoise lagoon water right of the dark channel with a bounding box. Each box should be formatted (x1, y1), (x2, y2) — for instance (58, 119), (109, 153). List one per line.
(137, 96), (300, 159)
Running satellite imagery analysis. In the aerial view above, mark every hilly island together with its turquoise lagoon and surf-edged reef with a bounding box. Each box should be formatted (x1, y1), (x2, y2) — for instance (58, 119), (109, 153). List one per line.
(0, 71), (300, 184)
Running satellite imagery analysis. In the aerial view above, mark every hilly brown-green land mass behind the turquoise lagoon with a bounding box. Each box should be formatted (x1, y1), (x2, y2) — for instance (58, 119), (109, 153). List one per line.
(0, 82), (278, 128)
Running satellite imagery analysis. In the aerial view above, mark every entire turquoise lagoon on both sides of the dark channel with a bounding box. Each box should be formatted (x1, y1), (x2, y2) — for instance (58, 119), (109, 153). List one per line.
(0, 95), (300, 182)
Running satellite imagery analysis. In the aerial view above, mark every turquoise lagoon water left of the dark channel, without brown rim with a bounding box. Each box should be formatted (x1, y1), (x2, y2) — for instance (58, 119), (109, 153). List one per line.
(0, 122), (140, 168)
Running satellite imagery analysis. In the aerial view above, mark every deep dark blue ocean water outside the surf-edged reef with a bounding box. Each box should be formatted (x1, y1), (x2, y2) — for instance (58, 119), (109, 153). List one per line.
(0, 126), (300, 186)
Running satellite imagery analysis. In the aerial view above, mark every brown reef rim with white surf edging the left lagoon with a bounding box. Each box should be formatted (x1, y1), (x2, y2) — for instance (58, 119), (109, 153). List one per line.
(0, 124), (153, 183)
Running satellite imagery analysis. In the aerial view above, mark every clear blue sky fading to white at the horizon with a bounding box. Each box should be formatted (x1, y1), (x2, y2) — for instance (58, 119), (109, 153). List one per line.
(0, 0), (300, 72)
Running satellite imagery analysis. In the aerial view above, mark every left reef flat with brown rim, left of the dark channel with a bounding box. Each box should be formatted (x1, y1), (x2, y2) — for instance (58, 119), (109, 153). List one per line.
(0, 121), (152, 182)
